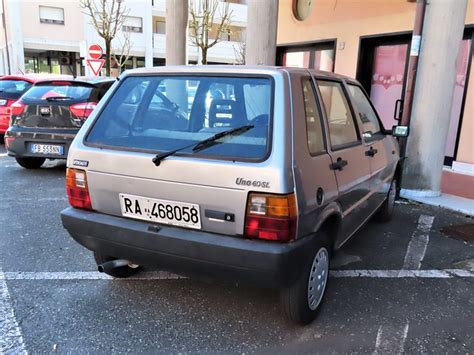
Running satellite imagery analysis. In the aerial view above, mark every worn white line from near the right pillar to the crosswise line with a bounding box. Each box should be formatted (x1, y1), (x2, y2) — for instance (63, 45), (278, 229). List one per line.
(402, 215), (434, 270)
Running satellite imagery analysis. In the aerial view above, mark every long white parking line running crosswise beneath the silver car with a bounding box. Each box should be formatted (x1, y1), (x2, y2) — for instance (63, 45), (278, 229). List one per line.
(0, 269), (474, 280)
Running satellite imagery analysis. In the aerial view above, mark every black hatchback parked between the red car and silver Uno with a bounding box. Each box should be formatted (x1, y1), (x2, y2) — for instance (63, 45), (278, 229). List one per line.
(5, 77), (113, 169)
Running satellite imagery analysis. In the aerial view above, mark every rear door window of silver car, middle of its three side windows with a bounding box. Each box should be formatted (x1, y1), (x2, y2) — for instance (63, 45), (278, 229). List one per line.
(318, 80), (359, 149)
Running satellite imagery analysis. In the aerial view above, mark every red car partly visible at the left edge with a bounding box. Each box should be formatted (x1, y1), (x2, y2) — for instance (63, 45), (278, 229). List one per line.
(0, 74), (65, 136)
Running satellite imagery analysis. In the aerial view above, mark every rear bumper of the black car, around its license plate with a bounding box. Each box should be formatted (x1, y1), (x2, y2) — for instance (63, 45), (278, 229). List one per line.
(5, 126), (79, 159)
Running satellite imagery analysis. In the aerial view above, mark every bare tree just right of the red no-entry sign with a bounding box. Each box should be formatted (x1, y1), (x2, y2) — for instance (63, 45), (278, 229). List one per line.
(80, 0), (128, 76)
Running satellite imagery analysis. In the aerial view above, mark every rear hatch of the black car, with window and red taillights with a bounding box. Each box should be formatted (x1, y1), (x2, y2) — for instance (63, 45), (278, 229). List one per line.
(12, 80), (98, 129)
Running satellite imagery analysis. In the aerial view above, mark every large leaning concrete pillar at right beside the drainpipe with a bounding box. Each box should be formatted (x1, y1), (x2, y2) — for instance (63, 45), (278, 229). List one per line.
(401, 0), (467, 197)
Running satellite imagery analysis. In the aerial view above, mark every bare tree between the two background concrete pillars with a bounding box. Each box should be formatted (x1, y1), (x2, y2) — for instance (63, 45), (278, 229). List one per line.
(189, 0), (232, 64)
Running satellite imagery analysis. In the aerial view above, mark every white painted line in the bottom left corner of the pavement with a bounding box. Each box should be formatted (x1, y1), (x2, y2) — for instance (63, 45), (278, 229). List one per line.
(0, 270), (26, 354)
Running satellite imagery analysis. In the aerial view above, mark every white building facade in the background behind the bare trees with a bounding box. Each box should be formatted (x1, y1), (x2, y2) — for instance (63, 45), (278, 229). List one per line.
(0, 0), (247, 75)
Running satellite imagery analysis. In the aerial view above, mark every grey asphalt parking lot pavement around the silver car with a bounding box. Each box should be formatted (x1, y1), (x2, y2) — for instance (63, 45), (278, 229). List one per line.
(0, 145), (474, 354)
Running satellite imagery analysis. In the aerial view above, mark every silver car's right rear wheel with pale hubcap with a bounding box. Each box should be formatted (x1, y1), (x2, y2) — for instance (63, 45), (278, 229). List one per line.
(280, 233), (331, 325)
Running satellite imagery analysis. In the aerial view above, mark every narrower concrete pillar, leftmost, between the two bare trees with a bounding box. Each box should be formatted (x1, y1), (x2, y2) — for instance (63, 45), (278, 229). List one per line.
(166, 0), (188, 65)
